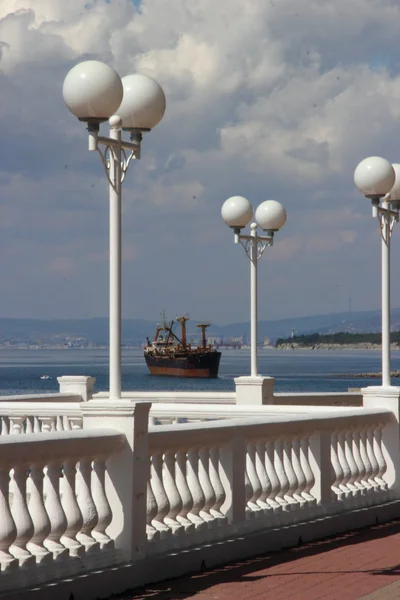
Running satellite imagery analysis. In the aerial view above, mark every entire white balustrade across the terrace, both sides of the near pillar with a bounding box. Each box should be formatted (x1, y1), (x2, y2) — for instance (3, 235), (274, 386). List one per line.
(0, 396), (399, 591)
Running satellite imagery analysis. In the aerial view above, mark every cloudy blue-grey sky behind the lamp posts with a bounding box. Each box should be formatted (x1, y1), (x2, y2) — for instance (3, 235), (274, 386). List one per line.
(0, 0), (400, 324)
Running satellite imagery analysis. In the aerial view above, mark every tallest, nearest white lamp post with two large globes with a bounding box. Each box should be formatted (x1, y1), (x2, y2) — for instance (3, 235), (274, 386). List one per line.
(63, 60), (165, 400)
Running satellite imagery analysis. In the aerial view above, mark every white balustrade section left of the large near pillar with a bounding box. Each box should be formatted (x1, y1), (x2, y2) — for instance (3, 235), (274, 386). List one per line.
(0, 429), (124, 590)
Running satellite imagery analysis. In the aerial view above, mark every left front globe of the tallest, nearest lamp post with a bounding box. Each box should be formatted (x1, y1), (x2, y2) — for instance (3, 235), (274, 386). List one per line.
(63, 60), (124, 122)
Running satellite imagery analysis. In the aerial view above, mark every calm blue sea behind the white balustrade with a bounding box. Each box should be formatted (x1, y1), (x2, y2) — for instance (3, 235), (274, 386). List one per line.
(0, 349), (400, 395)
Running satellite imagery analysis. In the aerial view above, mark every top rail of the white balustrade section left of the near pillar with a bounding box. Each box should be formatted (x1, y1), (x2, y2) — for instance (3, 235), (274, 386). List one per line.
(0, 429), (125, 466)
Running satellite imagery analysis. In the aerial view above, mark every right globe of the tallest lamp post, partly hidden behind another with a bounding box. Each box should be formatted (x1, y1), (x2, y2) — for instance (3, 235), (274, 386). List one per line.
(117, 74), (166, 131)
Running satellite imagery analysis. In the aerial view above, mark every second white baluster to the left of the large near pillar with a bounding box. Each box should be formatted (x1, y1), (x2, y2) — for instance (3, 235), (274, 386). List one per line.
(76, 456), (100, 554)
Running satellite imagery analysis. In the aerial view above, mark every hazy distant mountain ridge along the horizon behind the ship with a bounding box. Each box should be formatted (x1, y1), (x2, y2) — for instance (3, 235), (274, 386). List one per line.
(0, 308), (400, 345)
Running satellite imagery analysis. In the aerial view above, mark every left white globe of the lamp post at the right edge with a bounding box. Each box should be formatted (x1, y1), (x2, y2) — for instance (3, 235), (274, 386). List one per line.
(354, 156), (396, 198)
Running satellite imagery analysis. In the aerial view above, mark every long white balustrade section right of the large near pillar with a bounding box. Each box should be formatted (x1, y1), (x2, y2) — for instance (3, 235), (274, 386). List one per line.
(147, 409), (393, 551)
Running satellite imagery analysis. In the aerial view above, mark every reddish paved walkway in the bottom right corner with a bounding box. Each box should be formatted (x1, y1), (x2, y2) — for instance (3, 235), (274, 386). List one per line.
(115, 519), (400, 600)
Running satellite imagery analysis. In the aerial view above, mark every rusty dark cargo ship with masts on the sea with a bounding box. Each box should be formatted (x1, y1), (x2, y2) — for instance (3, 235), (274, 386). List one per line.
(144, 313), (221, 379)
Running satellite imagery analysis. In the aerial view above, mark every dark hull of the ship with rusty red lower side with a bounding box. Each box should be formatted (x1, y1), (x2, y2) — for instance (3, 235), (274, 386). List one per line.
(144, 351), (221, 379)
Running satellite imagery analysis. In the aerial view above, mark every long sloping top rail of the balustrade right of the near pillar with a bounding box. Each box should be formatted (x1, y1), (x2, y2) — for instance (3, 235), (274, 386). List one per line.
(149, 408), (395, 450)
